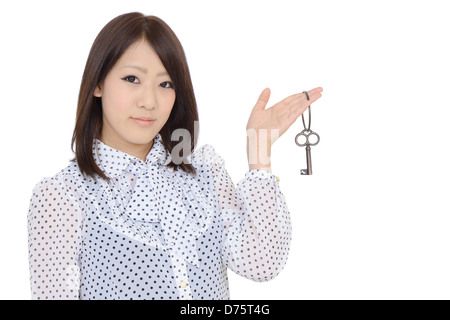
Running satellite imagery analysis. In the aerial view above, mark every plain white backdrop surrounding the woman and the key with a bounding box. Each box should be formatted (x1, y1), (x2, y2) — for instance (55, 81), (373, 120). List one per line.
(0, 0), (450, 299)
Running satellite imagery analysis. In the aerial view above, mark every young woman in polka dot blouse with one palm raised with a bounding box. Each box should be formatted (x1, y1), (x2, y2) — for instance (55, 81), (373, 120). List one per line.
(28, 12), (322, 299)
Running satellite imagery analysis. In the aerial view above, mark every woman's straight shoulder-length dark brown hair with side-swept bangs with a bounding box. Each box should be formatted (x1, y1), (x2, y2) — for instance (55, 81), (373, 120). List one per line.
(71, 12), (198, 181)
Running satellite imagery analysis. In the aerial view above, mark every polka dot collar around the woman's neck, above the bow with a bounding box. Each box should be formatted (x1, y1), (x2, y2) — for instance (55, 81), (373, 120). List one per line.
(92, 133), (171, 178)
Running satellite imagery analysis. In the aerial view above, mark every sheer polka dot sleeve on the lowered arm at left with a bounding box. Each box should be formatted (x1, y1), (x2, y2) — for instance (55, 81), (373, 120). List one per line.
(28, 176), (82, 300)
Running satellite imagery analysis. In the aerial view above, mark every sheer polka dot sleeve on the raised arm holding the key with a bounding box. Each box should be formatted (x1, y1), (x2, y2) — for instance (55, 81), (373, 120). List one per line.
(204, 147), (292, 281)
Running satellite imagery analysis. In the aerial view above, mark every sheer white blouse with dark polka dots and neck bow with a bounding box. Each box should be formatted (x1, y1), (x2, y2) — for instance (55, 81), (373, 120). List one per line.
(28, 134), (291, 299)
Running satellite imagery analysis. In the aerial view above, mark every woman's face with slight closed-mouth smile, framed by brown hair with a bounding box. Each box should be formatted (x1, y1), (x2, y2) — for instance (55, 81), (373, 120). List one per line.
(94, 40), (176, 159)
